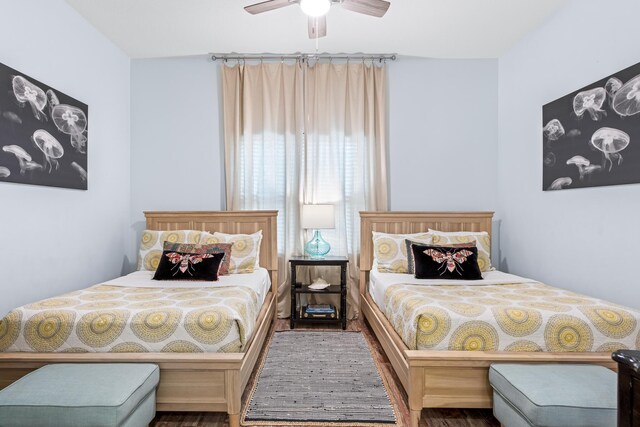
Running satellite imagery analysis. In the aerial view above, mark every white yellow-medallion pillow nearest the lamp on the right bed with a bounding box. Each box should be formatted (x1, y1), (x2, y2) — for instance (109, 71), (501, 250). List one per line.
(373, 231), (431, 273)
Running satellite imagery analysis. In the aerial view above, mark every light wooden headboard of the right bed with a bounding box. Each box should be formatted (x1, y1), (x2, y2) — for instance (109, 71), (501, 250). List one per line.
(360, 212), (493, 294)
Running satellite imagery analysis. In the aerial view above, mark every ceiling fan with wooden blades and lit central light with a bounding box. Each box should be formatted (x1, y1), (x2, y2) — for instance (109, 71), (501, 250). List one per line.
(244, 0), (391, 39)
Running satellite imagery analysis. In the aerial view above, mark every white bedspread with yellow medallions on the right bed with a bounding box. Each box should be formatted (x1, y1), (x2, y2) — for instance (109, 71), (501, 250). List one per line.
(384, 282), (640, 352)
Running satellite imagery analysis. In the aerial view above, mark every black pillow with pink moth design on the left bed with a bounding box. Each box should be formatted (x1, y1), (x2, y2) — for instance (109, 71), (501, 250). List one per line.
(153, 250), (224, 282)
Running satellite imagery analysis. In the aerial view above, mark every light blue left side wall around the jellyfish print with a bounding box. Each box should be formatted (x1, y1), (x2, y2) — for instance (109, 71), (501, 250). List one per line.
(0, 0), (131, 317)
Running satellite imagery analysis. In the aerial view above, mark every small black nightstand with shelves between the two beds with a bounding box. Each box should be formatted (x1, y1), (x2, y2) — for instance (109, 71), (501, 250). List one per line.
(289, 256), (349, 329)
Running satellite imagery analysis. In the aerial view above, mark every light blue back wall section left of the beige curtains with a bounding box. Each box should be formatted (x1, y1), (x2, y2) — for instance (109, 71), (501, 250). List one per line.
(130, 56), (224, 261)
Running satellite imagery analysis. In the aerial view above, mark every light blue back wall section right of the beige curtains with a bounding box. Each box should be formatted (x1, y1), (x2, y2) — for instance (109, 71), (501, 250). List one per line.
(389, 58), (498, 211)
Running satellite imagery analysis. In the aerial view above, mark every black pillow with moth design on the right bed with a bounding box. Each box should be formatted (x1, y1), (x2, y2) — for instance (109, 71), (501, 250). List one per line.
(411, 244), (482, 280)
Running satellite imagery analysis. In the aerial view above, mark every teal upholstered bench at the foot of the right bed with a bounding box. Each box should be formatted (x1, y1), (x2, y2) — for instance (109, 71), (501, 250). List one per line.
(489, 364), (617, 427)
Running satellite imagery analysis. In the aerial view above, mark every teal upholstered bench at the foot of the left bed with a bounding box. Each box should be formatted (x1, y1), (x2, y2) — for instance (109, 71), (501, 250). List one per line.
(0, 363), (160, 427)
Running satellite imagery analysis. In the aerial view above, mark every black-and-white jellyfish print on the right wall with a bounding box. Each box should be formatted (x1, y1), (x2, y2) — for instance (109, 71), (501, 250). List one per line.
(542, 60), (640, 190)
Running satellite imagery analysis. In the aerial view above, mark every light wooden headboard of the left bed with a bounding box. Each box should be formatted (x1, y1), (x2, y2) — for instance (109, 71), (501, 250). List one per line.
(144, 211), (278, 295)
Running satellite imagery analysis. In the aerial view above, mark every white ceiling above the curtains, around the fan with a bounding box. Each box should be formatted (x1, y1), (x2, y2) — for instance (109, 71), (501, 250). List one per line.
(66, 0), (567, 58)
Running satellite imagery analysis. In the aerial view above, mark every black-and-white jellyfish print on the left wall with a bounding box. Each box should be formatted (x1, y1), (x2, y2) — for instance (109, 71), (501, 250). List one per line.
(0, 64), (89, 190)
